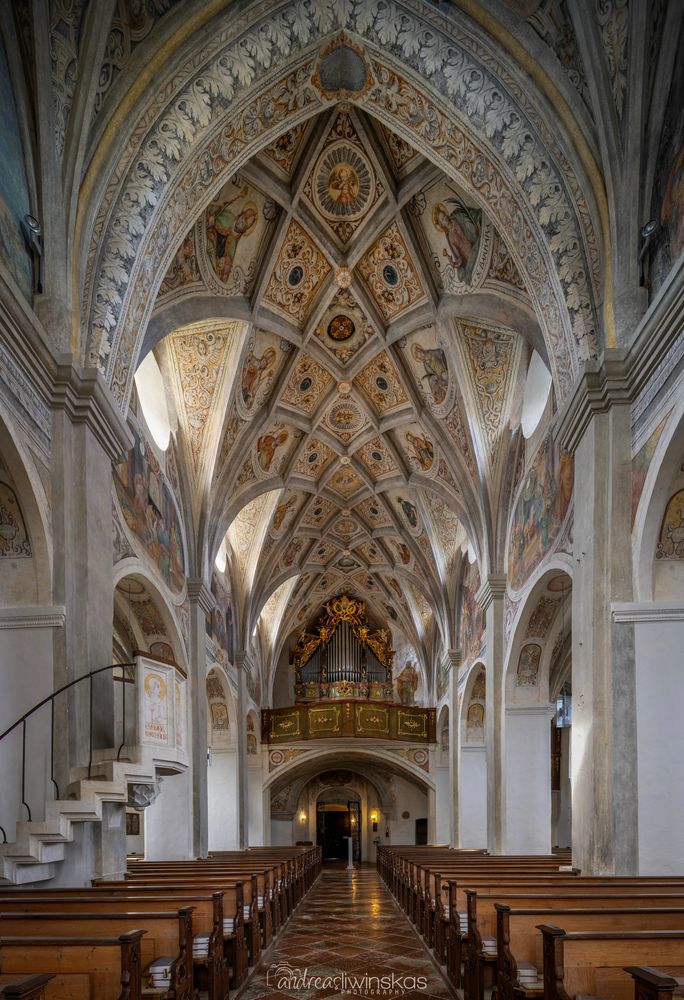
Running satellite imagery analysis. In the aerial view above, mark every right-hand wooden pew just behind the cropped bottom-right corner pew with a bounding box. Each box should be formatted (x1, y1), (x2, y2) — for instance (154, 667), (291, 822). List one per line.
(539, 924), (684, 1000)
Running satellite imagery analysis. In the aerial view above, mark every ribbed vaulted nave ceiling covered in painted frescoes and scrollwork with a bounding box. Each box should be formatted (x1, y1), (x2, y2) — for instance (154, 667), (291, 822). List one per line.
(148, 105), (541, 689)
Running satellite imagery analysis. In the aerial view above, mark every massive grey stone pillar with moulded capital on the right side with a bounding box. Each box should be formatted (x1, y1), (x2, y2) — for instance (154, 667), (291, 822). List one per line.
(556, 351), (637, 875)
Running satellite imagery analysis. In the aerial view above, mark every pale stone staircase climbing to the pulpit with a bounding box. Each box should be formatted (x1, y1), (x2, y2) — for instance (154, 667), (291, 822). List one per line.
(0, 753), (156, 885)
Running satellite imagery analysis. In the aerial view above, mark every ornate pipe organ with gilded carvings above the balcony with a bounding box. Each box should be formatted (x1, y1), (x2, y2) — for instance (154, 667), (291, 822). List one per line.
(290, 594), (394, 702)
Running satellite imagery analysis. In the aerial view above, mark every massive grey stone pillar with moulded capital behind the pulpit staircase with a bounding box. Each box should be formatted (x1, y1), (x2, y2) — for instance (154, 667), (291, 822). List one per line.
(52, 360), (133, 784)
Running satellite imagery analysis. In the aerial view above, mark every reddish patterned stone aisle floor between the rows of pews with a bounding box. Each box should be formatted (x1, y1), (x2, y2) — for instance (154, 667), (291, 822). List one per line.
(237, 866), (454, 1000)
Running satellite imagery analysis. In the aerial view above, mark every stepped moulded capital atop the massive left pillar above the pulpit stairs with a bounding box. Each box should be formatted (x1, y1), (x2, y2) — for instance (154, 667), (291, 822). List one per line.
(50, 355), (133, 462)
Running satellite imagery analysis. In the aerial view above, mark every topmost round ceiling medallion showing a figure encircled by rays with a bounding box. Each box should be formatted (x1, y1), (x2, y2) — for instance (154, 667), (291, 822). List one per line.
(312, 139), (375, 222)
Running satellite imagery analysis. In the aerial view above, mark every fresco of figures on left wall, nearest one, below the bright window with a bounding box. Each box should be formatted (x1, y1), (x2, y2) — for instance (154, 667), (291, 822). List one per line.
(114, 429), (185, 593)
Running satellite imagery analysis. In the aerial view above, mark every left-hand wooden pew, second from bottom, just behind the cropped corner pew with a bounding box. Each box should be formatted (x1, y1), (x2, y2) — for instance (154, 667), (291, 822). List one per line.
(0, 930), (144, 1000)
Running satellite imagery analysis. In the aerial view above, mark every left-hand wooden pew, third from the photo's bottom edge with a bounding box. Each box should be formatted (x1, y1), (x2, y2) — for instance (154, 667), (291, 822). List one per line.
(0, 906), (193, 1000)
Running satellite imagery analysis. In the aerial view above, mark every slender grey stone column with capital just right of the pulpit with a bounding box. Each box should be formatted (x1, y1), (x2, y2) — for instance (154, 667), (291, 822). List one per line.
(188, 579), (216, 858)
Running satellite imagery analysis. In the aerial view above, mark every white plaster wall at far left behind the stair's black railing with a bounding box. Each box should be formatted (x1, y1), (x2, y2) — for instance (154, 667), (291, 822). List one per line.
(0, 628), (54, 841)
